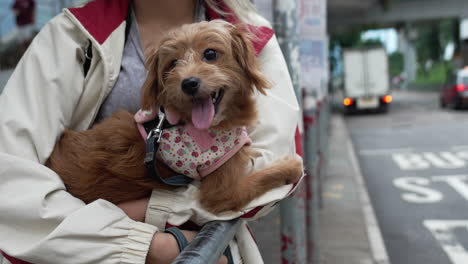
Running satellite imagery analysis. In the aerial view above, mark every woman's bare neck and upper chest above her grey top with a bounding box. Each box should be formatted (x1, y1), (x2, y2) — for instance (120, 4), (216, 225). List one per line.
(134, 0), (197, 53)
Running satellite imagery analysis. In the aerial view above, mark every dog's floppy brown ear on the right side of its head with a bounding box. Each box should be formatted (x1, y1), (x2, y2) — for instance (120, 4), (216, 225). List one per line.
(231, 25), (271, 94)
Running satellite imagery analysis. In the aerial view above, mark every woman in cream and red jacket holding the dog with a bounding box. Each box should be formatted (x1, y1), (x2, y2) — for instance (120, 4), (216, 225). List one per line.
(0, 0), (299, 264)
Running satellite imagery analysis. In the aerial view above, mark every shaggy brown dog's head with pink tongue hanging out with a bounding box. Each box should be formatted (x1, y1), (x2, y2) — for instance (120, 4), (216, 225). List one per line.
(142, 20), (269, 129)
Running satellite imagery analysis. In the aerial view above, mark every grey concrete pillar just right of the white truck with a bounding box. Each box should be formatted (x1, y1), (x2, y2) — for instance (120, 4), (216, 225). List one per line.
(398, 24), (418, 87)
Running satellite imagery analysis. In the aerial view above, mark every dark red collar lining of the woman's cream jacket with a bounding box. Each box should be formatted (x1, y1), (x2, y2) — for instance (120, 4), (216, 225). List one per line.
(65, 0), (274, 55)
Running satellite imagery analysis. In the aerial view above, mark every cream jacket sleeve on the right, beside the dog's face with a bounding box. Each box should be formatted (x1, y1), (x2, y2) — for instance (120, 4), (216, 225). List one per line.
(249, 33), (300, 170)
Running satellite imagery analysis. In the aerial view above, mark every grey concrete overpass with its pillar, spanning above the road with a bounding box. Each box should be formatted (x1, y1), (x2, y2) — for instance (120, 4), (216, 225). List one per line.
(328, 0), (468, 81)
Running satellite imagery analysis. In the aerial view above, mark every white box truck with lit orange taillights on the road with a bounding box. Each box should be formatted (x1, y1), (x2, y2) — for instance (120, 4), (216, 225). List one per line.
(343, 47), (392, 112)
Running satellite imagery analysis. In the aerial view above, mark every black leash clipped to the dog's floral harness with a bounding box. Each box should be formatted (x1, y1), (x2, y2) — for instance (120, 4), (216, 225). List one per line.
(143, 109), (193, 186)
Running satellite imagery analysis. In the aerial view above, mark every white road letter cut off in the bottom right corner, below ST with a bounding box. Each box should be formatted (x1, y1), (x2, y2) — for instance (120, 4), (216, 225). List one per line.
(423, 220), (468, 264)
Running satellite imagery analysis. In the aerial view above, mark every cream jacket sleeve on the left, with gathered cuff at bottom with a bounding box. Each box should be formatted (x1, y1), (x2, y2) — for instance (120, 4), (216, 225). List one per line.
(0, 15), (156, 264)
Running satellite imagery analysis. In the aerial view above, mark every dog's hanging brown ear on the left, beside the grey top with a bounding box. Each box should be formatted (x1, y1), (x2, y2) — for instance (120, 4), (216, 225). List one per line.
(141, 50), (160, 111)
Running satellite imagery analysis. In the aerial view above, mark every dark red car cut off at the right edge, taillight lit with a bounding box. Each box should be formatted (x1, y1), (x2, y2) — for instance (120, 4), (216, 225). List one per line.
(440, 67), (468, 109)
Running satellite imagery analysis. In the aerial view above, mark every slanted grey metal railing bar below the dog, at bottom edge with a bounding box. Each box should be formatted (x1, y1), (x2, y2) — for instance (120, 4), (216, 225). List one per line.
(172, 219), (241, 264)
